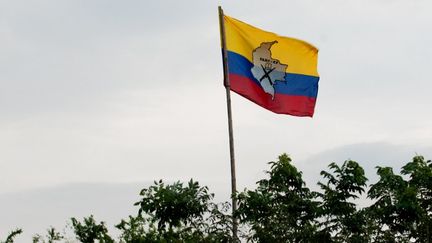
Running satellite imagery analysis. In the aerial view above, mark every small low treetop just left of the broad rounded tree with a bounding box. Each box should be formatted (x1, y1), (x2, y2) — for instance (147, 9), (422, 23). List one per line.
(71, 215), (114, 243)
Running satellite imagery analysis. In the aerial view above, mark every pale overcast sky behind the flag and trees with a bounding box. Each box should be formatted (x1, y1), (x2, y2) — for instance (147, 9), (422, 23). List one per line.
(0, 0), (432, 242)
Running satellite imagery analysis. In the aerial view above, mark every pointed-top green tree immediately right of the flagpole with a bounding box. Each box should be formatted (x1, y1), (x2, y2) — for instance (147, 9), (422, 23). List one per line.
(237, 154), (318, 242)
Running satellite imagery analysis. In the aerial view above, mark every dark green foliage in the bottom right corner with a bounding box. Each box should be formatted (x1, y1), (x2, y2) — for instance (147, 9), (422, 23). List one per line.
(368, 156), (432, 242)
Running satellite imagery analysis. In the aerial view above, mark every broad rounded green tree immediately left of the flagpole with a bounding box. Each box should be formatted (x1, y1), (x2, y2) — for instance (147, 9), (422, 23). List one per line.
(134, 180), (231, 242)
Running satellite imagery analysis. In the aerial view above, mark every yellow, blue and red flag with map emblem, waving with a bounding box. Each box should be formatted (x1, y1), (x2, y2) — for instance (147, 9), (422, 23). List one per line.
(223, 15), (319, 117)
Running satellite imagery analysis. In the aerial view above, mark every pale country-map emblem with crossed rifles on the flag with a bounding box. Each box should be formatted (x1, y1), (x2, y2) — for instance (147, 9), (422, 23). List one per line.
(251, 41), (288, 100)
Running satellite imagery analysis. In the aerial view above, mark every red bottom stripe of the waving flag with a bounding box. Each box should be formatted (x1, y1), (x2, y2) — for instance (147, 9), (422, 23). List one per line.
(229, 74), (316, 117)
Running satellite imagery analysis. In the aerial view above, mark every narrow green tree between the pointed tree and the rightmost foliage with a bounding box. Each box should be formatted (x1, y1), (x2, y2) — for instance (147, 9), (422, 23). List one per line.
(318, 160), (370, 242)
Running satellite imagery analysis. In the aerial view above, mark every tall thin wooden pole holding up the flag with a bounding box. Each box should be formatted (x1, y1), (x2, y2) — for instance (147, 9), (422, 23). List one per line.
(218, 6), (238, 242)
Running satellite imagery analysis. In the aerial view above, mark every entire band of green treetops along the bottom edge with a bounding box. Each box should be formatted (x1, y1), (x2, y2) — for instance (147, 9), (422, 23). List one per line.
(1, 154), (432, 243)
